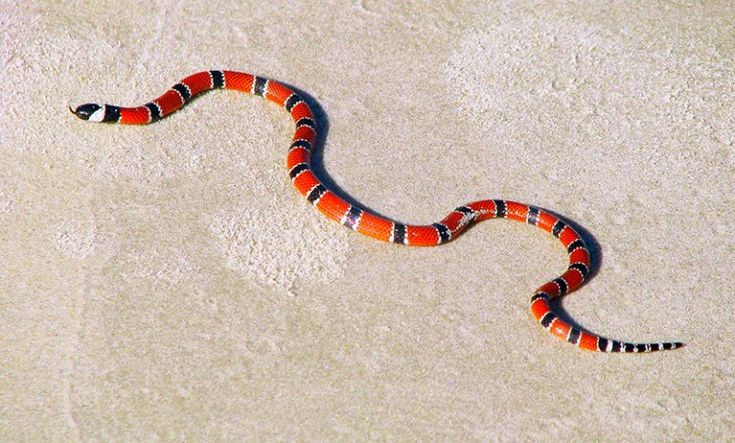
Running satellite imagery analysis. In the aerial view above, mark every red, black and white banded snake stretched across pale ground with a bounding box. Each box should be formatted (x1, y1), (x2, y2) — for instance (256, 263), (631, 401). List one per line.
(69, 70), (684, 353)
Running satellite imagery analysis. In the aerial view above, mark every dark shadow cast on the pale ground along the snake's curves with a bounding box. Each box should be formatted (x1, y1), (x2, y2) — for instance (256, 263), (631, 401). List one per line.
(284, 83), (603, 331)
